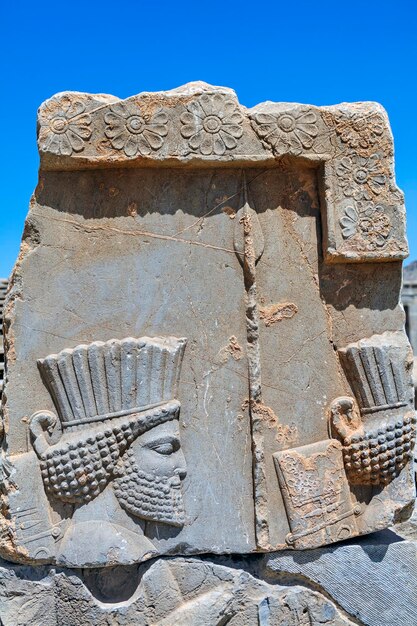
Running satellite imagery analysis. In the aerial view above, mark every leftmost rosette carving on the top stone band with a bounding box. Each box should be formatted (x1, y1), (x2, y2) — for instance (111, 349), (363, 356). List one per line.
(38, 96), (92, 156)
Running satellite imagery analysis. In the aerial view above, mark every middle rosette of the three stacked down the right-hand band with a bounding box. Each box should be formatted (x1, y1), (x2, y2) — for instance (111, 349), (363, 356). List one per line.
(336, 154), (386, 200)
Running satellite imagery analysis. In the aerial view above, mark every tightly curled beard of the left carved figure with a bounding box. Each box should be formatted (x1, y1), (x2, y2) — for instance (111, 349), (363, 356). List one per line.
(113, 450), (185, 526)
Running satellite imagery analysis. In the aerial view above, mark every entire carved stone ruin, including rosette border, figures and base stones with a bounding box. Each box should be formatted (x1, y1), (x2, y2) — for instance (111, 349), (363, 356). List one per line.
(0, 83), (417, 626)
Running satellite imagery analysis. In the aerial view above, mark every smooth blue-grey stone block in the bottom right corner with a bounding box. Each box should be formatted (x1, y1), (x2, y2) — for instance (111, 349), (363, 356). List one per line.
(261, 530), (417, 626)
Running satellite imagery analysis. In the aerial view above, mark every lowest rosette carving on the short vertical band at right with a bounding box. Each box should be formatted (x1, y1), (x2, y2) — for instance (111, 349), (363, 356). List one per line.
(339, 205), (392, 250)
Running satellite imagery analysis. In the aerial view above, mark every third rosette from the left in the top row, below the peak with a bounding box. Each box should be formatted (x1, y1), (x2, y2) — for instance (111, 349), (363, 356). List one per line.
(180, 94), (243, 156)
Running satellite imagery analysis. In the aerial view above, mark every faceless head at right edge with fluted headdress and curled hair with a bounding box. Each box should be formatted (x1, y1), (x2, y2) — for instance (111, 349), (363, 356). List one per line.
(330, 332), (416, 486)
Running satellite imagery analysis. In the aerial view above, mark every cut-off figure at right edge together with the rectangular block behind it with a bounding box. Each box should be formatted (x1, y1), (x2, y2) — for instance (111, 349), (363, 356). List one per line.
(273, 332), (416, 548)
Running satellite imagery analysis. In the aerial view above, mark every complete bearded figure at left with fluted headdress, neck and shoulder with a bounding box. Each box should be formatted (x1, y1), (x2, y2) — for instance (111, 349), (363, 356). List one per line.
(30, 337), (186, 566)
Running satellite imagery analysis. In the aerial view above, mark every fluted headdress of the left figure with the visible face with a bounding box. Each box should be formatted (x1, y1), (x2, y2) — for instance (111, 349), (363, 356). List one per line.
(38, 337), (186, 429)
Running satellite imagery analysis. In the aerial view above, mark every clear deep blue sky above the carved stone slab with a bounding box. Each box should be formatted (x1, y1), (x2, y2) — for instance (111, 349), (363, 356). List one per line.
(0, 0), (417, 276)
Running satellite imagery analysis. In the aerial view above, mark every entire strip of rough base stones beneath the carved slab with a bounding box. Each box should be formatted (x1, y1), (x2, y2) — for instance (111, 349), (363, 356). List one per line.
(0, 531), (417, 626)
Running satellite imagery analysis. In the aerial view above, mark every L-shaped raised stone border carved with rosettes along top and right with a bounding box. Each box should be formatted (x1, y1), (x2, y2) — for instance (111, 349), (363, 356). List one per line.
(38, 82), (407, 262)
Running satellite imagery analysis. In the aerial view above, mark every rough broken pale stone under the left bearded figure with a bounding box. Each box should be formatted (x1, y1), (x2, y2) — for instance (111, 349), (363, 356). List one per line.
(0, 558), (360, 626)
